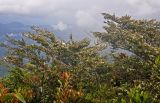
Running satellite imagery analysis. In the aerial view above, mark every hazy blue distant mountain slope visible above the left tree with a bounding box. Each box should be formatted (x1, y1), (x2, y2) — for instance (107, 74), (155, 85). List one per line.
(0, 22), (70, 41)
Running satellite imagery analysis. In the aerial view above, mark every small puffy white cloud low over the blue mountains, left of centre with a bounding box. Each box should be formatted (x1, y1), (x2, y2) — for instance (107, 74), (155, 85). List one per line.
(52, 21), (68, 31)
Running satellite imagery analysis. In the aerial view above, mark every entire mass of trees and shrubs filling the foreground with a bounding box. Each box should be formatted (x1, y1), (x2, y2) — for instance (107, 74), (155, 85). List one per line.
(0, 13), (160, 103)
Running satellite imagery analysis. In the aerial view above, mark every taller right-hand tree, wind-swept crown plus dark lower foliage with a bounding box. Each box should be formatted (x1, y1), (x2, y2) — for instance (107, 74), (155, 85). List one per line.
(94, 13), (160, 100)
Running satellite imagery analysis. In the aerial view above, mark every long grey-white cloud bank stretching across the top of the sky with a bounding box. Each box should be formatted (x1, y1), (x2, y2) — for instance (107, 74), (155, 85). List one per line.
(0, 0), (160, 16)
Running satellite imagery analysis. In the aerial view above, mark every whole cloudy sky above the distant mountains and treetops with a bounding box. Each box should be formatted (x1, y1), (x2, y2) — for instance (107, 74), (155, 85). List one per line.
(0, 0), (160, 36)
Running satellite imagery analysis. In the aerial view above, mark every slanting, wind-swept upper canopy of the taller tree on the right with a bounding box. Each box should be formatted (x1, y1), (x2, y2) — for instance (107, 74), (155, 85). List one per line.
(94, 13), (160, 64)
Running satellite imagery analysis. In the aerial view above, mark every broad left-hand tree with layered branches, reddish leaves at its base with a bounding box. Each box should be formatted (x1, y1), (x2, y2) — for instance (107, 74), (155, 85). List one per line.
(1, 27), (106, 103)
